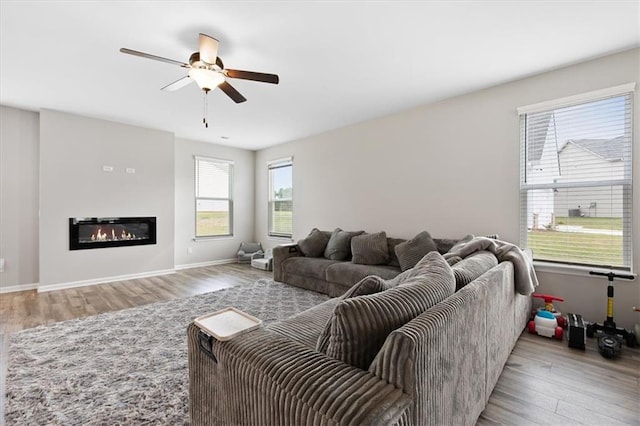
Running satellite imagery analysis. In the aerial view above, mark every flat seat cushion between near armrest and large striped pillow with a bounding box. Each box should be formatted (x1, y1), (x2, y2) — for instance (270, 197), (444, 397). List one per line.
(266, 297), (341, 349)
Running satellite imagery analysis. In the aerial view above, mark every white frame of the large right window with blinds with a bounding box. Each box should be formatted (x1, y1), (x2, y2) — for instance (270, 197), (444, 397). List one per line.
(517, 83), (637, 272)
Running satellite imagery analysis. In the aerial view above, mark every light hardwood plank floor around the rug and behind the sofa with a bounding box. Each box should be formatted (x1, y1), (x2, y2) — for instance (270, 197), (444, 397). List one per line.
(0, 264), (640, 425)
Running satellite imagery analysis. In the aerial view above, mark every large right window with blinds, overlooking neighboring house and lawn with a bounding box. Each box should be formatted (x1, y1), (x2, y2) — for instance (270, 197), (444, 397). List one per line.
(518, 84), (634, 271)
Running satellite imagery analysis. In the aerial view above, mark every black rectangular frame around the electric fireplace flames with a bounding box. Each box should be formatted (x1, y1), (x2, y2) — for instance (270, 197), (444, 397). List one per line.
(69, 217), (156, 250)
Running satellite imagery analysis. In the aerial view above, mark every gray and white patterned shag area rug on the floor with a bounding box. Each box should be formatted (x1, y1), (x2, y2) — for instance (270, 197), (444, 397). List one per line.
(5, 279), (328, 425)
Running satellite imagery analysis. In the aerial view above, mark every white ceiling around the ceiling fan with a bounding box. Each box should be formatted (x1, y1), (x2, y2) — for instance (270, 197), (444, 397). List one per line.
(0, 0), (640, 149)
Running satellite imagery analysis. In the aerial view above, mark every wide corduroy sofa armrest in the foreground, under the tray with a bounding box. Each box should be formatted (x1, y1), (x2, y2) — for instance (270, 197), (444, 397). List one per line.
(188, 324), (412, 425)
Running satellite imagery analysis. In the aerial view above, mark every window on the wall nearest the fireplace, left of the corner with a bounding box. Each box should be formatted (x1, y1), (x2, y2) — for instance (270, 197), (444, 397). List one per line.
(195, 157), (233, 238)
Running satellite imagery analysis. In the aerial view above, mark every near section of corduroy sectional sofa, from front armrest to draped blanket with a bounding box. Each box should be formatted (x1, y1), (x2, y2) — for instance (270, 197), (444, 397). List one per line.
(188, 239), (536, 425)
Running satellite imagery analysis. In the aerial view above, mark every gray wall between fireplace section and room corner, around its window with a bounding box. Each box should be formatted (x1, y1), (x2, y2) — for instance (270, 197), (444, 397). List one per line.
(175, 138), (255, 268)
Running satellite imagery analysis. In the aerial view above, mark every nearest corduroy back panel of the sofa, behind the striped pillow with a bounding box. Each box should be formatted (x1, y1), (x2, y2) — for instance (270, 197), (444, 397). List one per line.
(369, 272), (488, 425)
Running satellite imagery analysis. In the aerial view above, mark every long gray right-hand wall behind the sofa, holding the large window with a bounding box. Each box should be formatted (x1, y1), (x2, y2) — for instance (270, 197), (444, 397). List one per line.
(255, 49), (640, 327)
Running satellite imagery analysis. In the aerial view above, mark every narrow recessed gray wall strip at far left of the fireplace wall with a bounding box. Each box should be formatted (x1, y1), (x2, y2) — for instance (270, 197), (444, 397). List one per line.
(0, 106), (39, 292)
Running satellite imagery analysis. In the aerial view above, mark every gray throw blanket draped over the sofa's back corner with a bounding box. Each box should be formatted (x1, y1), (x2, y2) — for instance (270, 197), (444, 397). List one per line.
(444, 237), (538, 295)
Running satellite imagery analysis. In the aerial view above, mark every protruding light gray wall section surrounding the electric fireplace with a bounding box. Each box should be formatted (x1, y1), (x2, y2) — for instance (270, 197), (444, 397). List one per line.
(39, 110), (175, 286)
